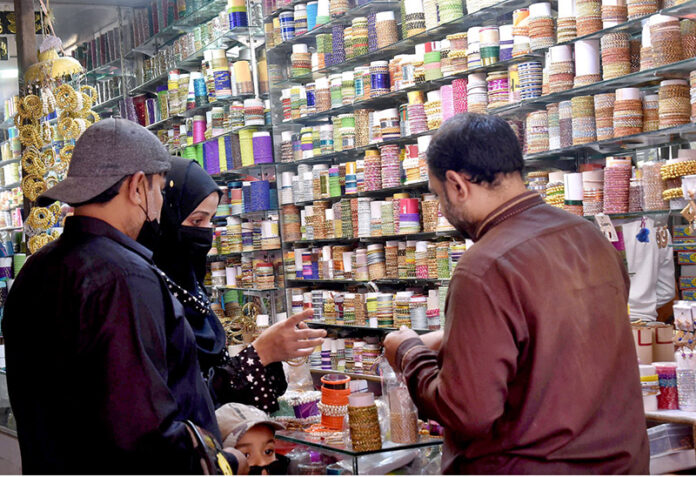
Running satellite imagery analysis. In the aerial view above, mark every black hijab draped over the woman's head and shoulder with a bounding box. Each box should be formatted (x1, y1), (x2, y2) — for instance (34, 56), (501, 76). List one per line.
(153, 157), (225, 368)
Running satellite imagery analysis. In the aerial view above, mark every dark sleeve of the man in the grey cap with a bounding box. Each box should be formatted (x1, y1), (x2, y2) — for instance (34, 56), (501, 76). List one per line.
(81, 275), (213, 474)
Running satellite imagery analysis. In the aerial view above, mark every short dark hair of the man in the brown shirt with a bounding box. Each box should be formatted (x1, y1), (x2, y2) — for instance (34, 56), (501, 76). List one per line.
(427, 113), (524, 185)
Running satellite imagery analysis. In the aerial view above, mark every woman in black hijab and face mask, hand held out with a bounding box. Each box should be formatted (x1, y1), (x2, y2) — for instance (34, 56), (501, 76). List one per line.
(145, 158), (326, 412)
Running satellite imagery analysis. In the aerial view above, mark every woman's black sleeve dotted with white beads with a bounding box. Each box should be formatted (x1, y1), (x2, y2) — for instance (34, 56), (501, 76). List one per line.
(209, 345), (288, 413)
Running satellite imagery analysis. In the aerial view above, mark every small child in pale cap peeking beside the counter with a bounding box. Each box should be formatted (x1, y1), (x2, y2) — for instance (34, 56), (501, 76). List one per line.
(215, 403), (289, 475)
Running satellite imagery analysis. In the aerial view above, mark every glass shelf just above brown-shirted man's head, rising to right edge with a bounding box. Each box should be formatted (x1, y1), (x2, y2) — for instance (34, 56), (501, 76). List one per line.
(488, 58), (696, 116)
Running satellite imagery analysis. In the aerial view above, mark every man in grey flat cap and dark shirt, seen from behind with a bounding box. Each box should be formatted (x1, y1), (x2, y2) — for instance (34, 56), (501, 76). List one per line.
(2, 119), (245, 474)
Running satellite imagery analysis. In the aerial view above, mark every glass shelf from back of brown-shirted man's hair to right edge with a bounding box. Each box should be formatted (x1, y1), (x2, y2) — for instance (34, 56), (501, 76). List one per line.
(524, 123), (696, 162)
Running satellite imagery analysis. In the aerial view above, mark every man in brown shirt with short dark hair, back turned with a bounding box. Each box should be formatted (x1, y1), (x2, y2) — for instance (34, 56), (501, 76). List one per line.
(385, 114), (649, 474)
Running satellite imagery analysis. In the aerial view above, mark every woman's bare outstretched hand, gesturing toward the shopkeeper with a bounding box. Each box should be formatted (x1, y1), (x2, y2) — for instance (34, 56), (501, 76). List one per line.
(252, 308), (326, 366)
